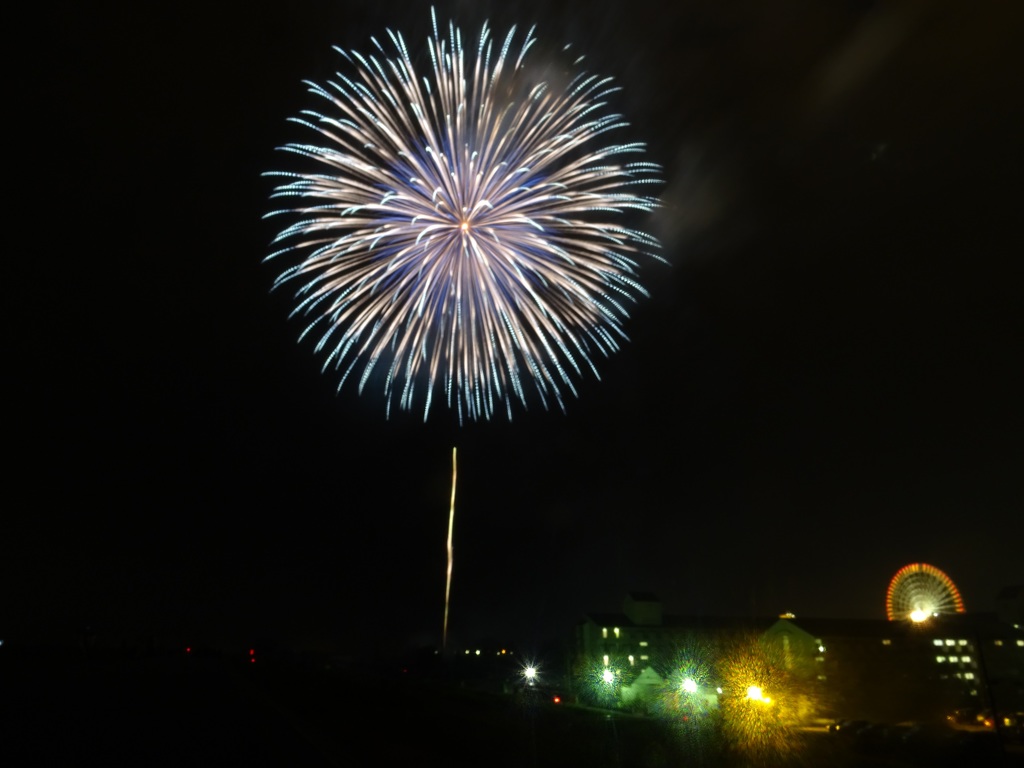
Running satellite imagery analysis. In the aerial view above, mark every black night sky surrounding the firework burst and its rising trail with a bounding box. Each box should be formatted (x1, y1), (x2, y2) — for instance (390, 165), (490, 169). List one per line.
(8, 0), (1024, 663)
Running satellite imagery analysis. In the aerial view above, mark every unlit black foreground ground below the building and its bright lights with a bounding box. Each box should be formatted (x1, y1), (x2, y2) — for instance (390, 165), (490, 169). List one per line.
(0, 654), (1024, 768)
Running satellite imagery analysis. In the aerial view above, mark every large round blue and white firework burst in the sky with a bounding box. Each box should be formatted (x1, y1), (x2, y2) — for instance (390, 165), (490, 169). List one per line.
(267, 10), (659, 422)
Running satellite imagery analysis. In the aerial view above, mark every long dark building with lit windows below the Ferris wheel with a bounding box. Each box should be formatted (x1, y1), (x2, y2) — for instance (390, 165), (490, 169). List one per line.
(573, 593), (1024, 723)
